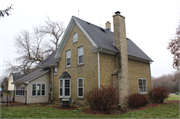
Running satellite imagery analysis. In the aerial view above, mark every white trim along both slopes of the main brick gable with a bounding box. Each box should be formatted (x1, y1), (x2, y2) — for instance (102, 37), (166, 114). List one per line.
(54, 17), (97, 59)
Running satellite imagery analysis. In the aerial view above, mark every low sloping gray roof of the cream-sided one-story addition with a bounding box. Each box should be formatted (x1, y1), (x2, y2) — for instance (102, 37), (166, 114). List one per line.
(12, 69), (49, 84)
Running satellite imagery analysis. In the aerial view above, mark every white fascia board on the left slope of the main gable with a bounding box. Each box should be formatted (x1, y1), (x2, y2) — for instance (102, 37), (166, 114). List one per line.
(54, 17), (75, 59)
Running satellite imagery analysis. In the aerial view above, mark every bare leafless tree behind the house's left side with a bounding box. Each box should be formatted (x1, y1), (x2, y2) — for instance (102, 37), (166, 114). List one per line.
(5, 18), (64, 74)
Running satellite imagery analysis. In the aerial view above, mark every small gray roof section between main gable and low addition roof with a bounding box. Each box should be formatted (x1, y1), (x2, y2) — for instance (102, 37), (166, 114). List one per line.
(40, 49), (59, 67)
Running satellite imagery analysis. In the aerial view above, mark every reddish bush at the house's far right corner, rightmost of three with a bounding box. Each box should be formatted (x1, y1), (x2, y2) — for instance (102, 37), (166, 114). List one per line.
(149, 86), (169, 103)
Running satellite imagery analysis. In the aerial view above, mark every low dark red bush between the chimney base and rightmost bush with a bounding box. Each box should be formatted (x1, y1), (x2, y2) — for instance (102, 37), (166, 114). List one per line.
(128, 94), (148, 108)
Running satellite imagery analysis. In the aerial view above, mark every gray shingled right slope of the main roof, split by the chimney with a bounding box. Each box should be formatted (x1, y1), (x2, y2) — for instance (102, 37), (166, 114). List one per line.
(73, 16), (152, 61)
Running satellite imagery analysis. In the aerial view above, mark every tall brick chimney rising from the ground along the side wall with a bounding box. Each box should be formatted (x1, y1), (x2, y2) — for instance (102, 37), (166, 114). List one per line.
(113, 11), (129, 105)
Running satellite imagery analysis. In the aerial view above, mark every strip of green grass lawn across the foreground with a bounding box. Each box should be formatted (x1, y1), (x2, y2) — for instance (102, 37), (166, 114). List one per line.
(1, 103), (179, 118)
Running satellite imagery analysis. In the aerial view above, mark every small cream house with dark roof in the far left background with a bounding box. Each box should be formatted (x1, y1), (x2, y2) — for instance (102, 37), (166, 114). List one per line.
(8, 73), (24, 91)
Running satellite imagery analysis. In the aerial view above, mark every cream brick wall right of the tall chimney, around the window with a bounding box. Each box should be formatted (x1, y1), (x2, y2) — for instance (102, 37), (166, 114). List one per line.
(128, 59), (151, 94)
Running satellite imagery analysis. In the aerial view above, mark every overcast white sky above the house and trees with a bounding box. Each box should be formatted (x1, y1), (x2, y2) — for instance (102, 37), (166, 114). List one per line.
(0, 0), (180, 77)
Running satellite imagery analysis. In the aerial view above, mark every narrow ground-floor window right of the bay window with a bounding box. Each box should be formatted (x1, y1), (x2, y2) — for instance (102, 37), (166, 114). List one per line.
(77, 78), (84, 97)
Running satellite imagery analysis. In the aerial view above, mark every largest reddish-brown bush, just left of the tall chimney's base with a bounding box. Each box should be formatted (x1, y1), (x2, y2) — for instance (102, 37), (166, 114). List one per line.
(85, 85), (119, 111)
